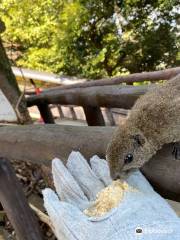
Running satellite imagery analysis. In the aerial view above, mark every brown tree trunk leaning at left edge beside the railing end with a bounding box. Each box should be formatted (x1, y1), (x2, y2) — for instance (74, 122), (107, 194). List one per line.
(0, 39), (30, 124)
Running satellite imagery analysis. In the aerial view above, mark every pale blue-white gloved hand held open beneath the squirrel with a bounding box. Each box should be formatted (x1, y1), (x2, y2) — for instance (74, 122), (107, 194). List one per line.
(43, 152), (180, 240)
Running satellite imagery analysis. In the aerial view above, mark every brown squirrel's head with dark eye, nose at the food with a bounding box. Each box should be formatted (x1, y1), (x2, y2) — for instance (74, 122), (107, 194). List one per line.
(106, 124), (154, 179)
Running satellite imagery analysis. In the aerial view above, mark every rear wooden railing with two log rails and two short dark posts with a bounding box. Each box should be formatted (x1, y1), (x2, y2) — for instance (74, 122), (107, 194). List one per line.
(27, 67), (180, 126)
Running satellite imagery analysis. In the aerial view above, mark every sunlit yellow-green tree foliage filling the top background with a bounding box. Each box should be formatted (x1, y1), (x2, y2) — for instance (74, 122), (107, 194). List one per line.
(0, 0), (179, 78)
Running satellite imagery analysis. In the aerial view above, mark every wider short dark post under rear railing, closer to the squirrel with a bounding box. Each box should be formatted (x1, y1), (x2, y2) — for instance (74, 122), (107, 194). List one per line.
(83, 106), (105, 126)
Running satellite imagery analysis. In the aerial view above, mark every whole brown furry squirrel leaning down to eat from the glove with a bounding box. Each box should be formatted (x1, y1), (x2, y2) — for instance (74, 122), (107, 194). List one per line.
(106, 75), (180, 179)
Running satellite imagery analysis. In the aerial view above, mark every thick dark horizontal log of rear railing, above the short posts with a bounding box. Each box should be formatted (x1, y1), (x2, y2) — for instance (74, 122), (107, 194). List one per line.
(27, 84), (150, 109)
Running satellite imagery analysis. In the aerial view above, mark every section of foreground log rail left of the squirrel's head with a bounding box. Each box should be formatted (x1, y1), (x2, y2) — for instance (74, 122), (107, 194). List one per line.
(0, 124), (113, 165)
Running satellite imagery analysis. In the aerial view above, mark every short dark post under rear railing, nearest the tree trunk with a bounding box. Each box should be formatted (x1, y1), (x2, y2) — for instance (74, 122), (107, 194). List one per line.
(37, 103), (55, 124)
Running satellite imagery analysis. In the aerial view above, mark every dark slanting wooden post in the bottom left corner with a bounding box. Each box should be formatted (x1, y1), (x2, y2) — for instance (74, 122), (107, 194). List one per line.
(0, 157), (43, 240)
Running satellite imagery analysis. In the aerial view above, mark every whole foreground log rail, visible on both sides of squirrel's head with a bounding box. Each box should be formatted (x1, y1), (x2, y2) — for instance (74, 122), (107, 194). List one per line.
(0, 124), (180, 201)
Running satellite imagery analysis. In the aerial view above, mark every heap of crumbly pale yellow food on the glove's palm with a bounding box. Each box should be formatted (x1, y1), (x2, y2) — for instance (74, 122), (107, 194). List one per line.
(84, 180), (134, 217)
